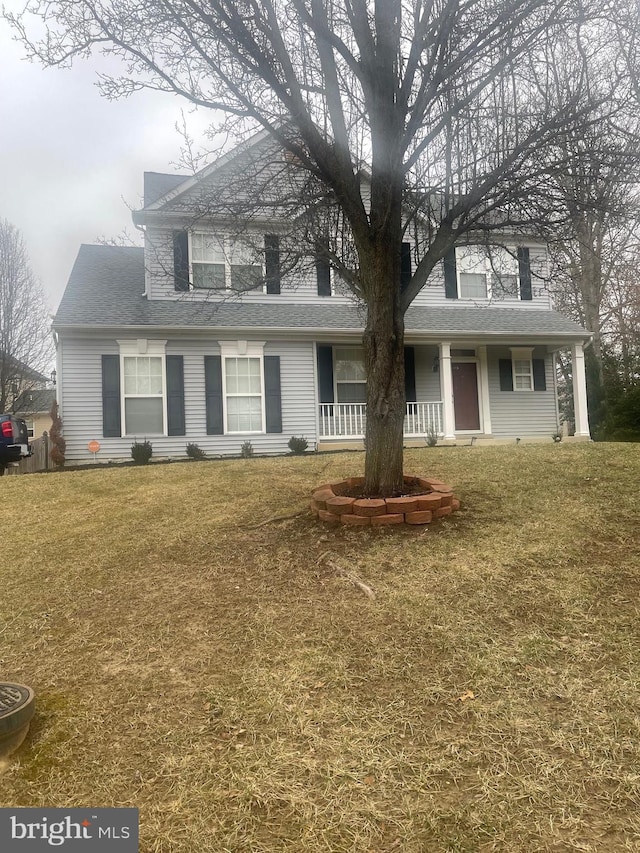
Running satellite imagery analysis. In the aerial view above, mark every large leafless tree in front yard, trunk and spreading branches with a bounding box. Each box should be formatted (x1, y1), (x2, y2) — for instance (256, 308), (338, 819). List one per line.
(10, 0), (628, 495)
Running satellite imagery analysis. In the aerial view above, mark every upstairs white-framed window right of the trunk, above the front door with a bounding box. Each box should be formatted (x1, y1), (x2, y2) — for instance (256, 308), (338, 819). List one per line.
(456, 246), (520, 300)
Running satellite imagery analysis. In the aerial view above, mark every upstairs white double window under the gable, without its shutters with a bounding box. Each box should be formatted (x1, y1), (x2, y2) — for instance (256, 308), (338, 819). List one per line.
(189, 231), (264, 293)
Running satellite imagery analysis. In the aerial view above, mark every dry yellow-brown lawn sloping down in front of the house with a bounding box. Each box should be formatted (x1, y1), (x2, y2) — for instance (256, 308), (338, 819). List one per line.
(0, 440), (640, 853)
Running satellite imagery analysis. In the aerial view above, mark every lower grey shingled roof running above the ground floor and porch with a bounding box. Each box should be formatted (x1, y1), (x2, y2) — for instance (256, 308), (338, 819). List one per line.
(53, 244), (590, 340)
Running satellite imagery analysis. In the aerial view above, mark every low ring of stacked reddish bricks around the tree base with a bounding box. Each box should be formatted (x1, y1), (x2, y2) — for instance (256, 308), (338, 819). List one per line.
(311, 475), (460, 527)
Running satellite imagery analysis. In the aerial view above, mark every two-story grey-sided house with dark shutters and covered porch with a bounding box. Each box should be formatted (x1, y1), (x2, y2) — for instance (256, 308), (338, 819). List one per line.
(54, 128), (589, 462)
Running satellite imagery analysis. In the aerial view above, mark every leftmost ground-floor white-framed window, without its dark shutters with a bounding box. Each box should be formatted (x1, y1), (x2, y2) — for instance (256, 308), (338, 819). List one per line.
(118, 339), (167, 437)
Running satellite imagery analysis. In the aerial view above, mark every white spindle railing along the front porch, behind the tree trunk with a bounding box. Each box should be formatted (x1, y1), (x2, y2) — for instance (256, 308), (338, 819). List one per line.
(320, 402), (444, 438)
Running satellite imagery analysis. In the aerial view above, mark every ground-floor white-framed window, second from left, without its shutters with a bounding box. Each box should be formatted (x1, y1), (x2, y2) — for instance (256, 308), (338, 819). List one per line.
(220, 341), (266, 434)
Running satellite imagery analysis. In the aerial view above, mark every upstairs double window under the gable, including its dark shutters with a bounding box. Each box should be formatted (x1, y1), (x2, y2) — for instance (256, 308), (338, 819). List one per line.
(173, 231), (280, 293)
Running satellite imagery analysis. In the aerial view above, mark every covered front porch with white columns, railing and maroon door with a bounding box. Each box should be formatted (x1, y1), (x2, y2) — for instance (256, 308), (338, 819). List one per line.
(317, 339), (589, 449)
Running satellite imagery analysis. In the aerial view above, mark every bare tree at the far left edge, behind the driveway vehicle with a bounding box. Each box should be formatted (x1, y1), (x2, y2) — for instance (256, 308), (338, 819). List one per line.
(0, 219), (53, 412)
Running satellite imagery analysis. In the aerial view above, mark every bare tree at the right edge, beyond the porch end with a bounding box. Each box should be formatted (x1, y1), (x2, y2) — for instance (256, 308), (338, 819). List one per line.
(545, 22), (640, 429)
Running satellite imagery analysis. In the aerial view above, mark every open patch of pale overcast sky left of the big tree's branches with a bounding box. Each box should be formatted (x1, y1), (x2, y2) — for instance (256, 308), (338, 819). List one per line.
(0, 15), (212, 312)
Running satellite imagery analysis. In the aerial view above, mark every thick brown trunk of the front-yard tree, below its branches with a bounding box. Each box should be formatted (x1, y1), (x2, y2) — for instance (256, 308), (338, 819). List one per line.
(364, 240), (405, 496)
